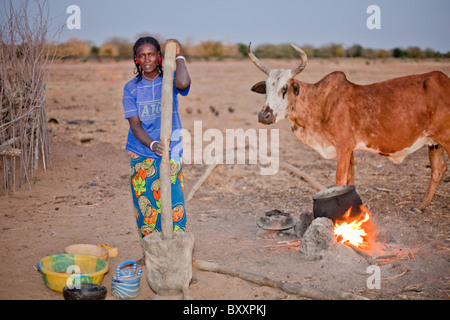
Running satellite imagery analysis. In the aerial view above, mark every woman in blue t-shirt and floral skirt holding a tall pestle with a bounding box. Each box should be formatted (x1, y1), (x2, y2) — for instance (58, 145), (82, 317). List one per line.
(123, 37), (191, 241)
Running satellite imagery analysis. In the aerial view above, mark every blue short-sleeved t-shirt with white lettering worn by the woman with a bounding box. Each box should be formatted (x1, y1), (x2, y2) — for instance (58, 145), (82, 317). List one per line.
(122, 72), (190, 159)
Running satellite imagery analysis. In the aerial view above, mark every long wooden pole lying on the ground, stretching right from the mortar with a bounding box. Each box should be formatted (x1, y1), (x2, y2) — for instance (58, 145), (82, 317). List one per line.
(193, 260), (369, 300)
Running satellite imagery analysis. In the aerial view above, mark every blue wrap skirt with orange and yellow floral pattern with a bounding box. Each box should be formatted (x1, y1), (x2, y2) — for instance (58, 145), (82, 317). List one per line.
(130, 153), (186, 241)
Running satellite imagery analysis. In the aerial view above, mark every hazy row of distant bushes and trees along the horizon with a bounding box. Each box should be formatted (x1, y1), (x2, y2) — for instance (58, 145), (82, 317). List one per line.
(54, 34), (444, 59)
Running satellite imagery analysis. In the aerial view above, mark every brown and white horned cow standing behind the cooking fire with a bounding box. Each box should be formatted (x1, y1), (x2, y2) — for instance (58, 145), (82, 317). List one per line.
(248, 43), (450, 211)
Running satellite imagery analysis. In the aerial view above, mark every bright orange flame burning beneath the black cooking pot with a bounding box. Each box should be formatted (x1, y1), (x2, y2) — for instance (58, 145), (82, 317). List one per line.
(334, 205), (370, 247)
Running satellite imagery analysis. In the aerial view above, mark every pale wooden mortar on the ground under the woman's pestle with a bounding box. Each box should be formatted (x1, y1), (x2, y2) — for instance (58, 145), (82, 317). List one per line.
(143, 232), (194, 300)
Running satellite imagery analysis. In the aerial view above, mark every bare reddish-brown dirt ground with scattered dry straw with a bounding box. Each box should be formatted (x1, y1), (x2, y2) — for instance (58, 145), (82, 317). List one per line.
(0, 59), (450, 300)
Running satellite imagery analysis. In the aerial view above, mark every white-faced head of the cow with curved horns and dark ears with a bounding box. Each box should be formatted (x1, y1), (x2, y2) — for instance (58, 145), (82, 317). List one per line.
(247, 42), (308, 124)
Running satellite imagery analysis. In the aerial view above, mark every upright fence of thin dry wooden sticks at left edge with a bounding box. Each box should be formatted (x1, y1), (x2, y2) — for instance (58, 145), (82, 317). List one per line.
(0, 1), (55, 194)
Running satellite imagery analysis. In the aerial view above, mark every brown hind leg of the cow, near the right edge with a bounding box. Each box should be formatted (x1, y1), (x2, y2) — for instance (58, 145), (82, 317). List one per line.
(418, 145), (447, 211)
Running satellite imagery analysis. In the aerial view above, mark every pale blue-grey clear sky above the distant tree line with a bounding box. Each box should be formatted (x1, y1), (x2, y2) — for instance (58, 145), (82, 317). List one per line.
(0, 0), (450, 52)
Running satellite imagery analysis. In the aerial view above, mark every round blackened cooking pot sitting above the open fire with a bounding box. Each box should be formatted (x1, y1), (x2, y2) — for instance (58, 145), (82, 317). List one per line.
(312, 185), (362, 222)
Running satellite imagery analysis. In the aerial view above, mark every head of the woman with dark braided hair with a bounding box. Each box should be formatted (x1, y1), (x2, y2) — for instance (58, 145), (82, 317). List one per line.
(133, 37), (162, 81)
